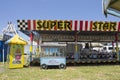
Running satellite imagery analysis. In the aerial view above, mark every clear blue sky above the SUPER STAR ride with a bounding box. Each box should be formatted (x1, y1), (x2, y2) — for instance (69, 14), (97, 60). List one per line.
(0, 0), (119, 35)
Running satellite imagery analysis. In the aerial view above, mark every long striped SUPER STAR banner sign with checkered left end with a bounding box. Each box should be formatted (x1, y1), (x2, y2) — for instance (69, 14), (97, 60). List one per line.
(17, 20), (120, 31)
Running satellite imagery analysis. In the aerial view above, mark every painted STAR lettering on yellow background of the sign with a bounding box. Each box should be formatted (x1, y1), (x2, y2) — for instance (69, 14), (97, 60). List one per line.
(92, 22), (117, 31)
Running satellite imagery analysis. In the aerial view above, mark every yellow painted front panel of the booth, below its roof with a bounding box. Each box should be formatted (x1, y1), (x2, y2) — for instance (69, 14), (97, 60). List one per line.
(9, 44), (24, 68)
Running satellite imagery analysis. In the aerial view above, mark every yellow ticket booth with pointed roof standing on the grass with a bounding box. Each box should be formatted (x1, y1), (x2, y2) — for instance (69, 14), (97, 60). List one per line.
(6, 35), (27, 68)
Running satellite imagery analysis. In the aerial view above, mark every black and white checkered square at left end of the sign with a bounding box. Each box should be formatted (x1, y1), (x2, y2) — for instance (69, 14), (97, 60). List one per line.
(17, 20), (28, 30)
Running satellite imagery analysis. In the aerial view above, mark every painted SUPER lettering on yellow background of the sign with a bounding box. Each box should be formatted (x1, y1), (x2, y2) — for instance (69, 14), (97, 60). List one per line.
(36, 20), (72, 30)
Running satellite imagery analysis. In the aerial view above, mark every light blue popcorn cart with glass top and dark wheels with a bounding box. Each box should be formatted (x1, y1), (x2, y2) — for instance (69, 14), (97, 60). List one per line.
(40, 43), (66, 69)
